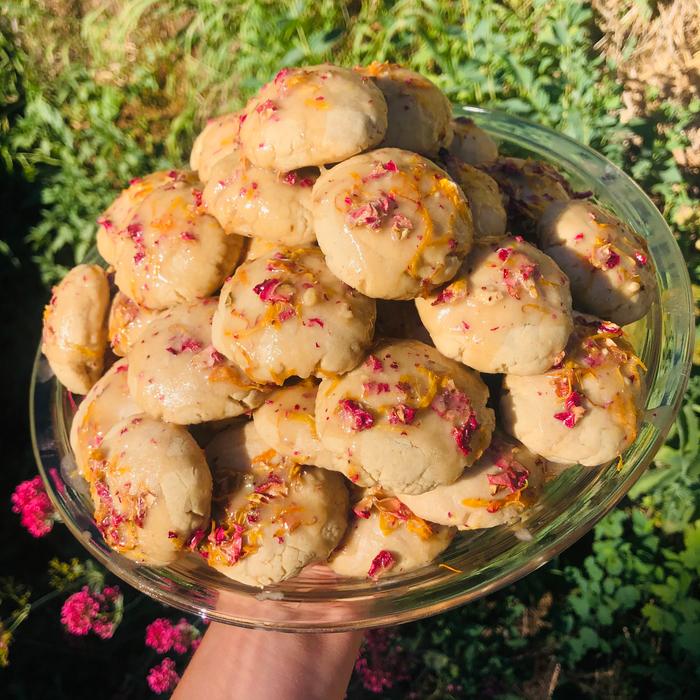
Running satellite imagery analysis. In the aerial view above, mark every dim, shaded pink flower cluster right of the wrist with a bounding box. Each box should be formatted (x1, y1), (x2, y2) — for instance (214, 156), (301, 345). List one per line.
(355, 629), (410, 695)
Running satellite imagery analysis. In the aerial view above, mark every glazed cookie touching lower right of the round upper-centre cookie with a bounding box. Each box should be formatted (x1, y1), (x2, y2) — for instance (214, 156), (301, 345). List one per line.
(416, 237), (573, 374)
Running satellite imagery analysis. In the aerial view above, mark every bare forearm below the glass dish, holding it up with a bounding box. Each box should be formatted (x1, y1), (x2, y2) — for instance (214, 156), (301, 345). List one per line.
(172, 622), (362, 700)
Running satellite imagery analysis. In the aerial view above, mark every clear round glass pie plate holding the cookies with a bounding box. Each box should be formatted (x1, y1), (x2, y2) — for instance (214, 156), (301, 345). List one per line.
(30, 107), (693, 632)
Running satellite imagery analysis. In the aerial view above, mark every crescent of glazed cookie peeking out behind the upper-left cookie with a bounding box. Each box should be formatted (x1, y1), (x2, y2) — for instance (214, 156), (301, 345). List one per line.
(97, 170), (197, 265)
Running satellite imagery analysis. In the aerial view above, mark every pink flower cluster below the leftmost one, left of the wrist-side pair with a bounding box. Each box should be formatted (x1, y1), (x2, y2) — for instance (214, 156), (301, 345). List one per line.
(61, 586), (123, 639)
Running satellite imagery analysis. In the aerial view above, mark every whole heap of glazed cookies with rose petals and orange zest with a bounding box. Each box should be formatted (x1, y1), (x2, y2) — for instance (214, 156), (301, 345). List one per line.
(42, 63), (656, 586)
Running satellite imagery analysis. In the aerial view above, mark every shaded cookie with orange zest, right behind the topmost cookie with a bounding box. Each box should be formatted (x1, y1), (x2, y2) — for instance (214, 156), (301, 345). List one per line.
(355, 61), (452, 154)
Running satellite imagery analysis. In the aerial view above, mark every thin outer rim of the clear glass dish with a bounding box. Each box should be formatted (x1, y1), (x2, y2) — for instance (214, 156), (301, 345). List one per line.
(30, 107), (693, 632)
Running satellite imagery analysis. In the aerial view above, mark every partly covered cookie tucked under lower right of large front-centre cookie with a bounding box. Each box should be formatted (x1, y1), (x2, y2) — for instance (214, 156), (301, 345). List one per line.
(399, 435), (545, 530)
